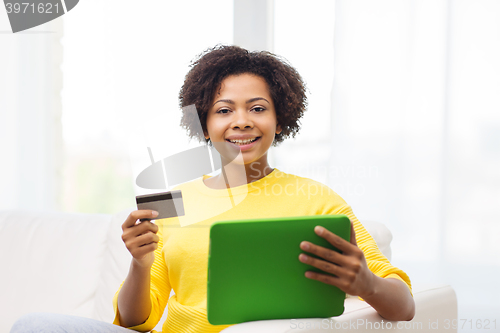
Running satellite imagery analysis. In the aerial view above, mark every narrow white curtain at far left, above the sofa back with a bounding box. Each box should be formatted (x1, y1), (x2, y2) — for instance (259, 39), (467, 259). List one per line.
(0, 19), (63, 210)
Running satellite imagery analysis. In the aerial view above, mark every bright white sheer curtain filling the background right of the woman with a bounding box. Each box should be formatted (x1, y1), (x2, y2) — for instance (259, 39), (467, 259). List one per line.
(275, 0), (500, 321)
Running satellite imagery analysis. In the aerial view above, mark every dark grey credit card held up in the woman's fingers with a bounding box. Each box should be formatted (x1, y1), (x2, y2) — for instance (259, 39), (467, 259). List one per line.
(135, 191), (184, 221)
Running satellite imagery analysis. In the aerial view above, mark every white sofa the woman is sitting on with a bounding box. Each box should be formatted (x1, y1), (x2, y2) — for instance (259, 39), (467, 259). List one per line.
(0, 211), (457, 333)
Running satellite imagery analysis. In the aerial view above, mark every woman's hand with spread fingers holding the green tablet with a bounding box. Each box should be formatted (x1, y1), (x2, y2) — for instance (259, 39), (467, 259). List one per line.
(299, 222), (375, 298)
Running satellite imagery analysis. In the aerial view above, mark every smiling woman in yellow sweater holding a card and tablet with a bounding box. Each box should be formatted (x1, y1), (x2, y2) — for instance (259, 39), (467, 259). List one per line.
(114, 46), (415, 332)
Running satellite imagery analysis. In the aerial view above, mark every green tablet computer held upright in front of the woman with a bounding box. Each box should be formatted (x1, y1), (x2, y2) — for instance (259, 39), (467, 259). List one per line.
(207, 215), (351, 325)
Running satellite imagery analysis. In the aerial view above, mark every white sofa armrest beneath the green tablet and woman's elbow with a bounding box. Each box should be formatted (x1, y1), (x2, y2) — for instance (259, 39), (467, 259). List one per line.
(222, 285), (457, 333)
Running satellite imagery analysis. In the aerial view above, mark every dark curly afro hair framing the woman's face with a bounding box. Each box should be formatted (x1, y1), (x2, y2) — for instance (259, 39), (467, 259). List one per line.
(179, 45), (307, 146)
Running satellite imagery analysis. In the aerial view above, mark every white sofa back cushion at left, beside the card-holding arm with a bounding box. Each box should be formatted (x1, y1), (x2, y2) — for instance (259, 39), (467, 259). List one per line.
(0, 211), (111, 332)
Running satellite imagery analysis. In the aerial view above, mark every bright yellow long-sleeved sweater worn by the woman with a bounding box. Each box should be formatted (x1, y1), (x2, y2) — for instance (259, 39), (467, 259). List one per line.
(113, 169), (411, 333)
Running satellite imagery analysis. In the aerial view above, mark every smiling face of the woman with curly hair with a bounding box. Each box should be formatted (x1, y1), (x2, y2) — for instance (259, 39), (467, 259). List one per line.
(205, 73), (281, 167)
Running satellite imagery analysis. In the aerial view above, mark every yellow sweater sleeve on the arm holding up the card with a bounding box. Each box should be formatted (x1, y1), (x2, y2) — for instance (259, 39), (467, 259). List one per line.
(113, 220), (172, 332)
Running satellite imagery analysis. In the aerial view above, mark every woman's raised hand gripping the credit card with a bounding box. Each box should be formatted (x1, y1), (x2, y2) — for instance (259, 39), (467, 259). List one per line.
(122, 210), (159, 267)
